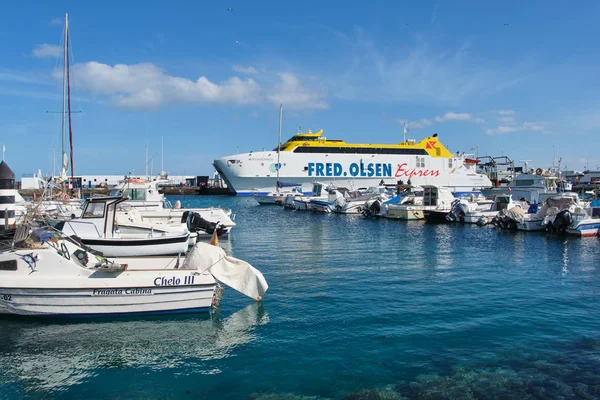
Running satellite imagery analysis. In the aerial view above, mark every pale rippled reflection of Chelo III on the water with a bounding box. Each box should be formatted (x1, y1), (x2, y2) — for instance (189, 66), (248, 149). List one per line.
(0, 303), (269, 391)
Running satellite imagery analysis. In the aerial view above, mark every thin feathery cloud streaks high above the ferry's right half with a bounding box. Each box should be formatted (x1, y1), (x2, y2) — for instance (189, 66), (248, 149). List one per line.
(328, 28), (529, 106)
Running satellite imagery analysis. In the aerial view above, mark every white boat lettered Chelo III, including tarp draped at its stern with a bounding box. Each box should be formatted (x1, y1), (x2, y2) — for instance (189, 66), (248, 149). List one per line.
(0, 228), (268, 317)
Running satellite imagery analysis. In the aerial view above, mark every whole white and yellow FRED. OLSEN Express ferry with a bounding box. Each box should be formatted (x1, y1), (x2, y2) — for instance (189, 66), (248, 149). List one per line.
(213, 130), (492, 196)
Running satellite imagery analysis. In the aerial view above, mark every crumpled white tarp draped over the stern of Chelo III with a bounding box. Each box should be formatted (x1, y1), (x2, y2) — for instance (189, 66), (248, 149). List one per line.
(182, 243), (269, 301)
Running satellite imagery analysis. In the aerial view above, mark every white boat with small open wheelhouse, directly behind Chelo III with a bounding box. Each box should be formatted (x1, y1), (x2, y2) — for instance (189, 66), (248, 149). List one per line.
(60, 197), (190, 257)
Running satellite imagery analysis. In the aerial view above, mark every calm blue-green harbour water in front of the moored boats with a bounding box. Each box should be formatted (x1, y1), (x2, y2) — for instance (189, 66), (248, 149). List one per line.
(0, 196), (600, 399)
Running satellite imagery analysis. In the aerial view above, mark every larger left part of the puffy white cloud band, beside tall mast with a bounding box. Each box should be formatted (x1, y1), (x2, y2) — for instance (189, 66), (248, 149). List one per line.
(73, 61), (261, 109)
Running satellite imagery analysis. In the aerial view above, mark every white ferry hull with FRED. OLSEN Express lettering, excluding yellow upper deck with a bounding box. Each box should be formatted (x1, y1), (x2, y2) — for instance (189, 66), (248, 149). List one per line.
(213, 151), (492, 196)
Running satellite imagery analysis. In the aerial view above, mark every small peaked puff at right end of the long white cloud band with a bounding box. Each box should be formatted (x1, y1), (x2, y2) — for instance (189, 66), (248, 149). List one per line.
(267, 72), (329, 109)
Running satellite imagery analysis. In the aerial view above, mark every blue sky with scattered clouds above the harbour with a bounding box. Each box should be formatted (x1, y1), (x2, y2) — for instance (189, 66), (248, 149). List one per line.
(0, 0), (600, 176)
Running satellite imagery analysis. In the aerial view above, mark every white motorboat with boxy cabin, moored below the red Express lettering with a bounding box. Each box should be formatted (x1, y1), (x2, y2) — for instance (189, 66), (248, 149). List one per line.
(384, 185), (454, 221)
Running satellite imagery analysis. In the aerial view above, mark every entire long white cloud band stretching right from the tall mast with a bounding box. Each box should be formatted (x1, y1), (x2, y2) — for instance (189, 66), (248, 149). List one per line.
(65, 61), (329, 110)
